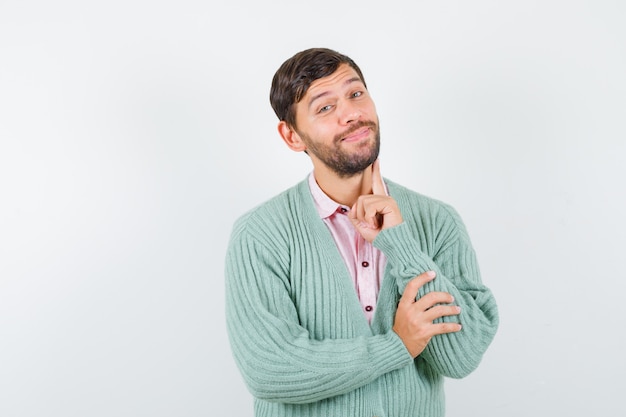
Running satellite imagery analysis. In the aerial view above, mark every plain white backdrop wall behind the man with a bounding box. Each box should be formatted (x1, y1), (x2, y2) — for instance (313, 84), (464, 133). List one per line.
(0, 0), (626, 417)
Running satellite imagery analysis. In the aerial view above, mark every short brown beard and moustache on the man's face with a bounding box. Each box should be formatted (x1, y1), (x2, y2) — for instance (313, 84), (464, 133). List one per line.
(300, 122), (380, 178)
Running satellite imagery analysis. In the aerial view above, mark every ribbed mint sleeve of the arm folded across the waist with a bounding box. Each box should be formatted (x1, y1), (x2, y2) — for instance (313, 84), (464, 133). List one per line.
(226, 219), (412, 403)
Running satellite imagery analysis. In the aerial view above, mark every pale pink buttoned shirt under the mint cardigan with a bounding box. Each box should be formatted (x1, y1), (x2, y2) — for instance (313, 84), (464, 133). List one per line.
(309, 173), (387, 323)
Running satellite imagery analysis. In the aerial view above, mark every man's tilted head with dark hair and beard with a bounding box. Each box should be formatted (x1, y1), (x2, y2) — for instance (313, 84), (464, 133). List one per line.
(270, 48), (380, 177)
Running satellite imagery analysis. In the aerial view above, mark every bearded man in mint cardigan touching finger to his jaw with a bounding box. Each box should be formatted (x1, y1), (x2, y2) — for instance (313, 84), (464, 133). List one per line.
(226, 48), (498, 417)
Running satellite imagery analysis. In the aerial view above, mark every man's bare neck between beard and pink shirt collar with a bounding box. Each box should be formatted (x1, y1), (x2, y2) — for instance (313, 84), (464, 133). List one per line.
(313, 165), (372, 207)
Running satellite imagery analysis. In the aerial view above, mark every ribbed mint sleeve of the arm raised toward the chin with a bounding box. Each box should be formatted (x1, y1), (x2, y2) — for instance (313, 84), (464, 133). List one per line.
(374, 184), (498, 378)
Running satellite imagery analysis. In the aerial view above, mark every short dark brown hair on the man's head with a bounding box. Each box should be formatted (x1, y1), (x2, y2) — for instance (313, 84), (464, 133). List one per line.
(270, 48), (367, 127)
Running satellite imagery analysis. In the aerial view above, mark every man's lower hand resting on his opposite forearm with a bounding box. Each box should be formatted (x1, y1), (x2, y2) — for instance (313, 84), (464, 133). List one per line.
(393, 271), (461, 358)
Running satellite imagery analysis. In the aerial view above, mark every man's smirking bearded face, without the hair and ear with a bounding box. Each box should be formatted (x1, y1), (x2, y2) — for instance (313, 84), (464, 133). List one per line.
(296, 64), (380, 177)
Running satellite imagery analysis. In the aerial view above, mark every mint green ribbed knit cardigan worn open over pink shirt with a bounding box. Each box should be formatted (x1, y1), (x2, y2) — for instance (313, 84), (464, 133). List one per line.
(225, 180), (498, 417)
